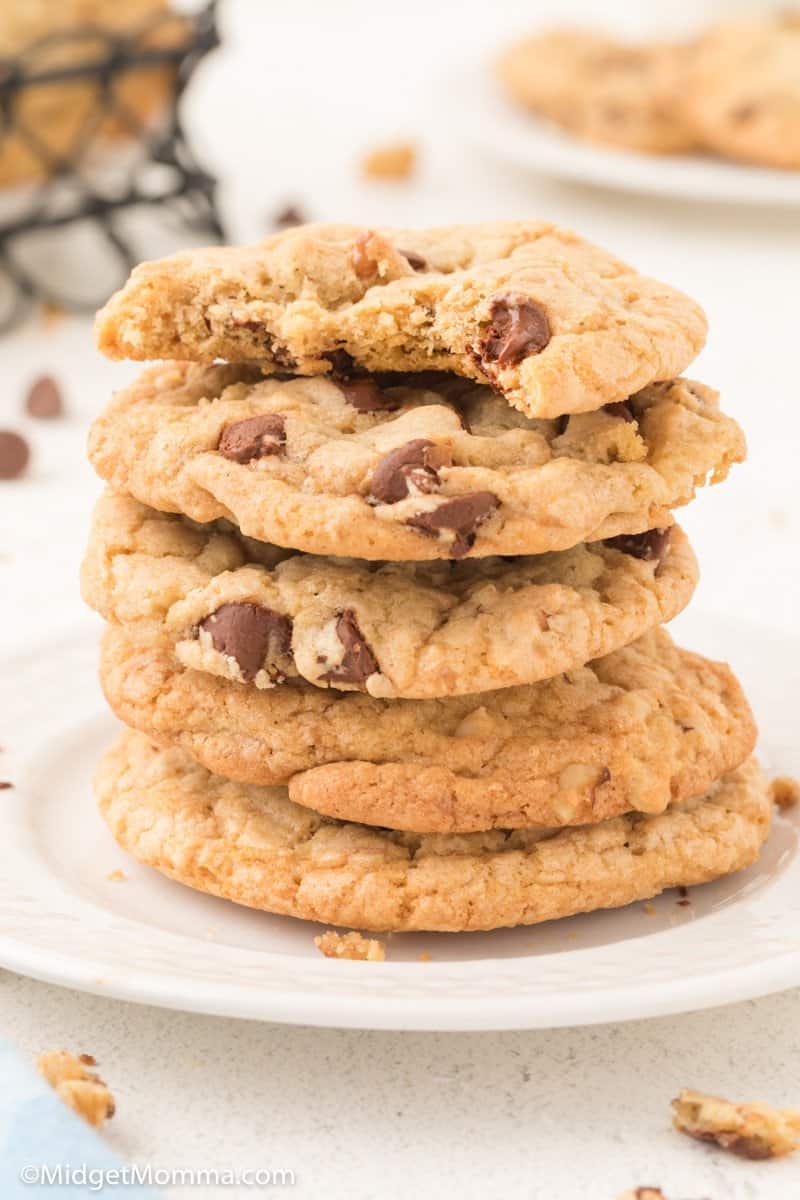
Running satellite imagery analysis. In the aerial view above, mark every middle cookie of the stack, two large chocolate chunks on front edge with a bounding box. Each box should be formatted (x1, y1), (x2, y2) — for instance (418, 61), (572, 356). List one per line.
(82, 493), (697, 698)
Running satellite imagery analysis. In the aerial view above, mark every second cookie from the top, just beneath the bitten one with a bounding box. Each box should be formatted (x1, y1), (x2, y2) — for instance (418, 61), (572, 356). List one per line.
(89, 364), (746, 560)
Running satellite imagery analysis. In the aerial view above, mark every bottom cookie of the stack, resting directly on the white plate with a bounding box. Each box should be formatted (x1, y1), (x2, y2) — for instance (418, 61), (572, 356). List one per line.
(96, 732), (771, 931)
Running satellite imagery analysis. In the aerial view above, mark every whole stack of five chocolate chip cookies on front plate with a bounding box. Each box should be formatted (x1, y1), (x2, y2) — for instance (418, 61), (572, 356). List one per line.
(83, 222), (770, 931)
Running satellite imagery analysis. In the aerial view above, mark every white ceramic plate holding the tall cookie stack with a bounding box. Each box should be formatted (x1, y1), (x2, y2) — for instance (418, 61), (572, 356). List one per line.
(0, 614), (800, 1030)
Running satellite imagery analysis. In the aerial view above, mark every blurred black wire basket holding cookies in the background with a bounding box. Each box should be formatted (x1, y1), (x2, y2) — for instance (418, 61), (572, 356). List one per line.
(0, 0), (224, 331)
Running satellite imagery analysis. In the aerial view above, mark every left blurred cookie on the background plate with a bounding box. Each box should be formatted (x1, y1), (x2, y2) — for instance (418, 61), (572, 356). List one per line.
(497, 29), (696, 154)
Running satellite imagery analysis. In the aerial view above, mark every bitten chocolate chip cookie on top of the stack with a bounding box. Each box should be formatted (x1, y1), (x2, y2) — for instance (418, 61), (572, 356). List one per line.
(96, 221), (706, 418)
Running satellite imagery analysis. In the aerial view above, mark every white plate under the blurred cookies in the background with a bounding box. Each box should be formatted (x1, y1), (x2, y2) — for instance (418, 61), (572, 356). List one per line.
(448, 62), (800, 206)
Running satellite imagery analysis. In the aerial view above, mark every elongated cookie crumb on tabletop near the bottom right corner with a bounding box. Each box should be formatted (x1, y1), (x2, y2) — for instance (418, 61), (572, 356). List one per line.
(672, 1088), (800, 1159)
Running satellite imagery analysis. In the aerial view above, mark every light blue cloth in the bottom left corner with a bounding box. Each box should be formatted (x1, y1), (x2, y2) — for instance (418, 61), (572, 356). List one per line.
(0, 1038), (156, 1200)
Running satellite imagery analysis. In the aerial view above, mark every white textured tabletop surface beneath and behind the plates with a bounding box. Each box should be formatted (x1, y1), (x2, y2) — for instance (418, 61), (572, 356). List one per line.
(0, 0), (800, 1200)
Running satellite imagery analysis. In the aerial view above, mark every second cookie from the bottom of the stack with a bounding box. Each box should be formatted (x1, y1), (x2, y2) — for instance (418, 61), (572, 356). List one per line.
(101, 625), (756, 833)
